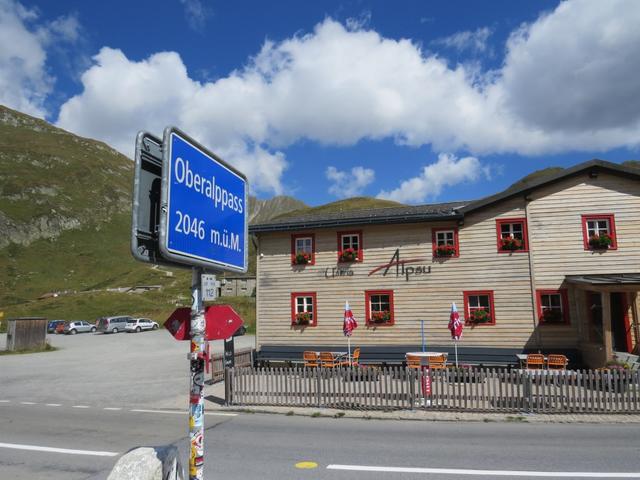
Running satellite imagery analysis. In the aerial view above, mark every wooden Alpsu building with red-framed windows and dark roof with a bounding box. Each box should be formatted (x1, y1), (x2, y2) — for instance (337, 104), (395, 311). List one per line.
(250, 160), (640, 367)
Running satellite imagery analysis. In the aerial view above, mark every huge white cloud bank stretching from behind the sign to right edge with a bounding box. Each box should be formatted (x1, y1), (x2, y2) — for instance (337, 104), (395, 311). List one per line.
(48, 0), (640, 194)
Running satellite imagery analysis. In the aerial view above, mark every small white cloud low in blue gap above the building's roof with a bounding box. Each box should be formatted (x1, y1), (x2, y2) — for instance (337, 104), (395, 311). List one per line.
(378, 153), (490, 203)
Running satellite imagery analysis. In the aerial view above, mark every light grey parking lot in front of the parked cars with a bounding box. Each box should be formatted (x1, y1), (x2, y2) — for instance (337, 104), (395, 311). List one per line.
(0, 329), (255, 409)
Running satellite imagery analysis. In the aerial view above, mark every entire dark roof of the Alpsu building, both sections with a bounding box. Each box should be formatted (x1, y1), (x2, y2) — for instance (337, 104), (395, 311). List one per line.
(249, 159), (640, 233)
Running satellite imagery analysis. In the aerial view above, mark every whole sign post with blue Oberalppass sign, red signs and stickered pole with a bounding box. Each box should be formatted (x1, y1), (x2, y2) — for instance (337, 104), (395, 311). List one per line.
(131, 127), (249, 480)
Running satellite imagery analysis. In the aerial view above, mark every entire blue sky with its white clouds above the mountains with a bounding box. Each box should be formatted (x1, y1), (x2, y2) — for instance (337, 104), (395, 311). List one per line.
(0, 0), (640, 205)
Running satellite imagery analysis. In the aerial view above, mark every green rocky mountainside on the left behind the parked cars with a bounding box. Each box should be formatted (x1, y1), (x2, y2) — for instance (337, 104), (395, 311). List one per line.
(0, 106), (306, 318)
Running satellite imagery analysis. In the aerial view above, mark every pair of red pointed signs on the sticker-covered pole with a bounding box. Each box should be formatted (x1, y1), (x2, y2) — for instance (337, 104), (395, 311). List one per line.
(164, 305), (244, 341)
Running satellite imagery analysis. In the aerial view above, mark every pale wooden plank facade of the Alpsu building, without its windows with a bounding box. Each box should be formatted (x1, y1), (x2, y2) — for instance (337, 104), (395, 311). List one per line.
(256, 162), (640, 366)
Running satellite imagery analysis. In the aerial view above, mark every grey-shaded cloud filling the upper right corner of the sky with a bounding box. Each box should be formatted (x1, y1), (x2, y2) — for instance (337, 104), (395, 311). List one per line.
(500, 0), (640, 132)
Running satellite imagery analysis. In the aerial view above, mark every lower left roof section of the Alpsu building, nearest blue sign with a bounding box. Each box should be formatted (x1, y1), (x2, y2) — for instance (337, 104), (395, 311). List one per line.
(249, 202), (468, 233)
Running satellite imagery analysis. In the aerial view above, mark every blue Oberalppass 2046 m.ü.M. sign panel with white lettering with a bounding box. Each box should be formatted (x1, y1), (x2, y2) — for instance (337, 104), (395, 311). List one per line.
(160, 127), (249, 272)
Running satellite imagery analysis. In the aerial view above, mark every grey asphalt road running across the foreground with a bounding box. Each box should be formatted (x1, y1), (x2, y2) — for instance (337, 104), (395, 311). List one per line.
(0, 402), (640, 480)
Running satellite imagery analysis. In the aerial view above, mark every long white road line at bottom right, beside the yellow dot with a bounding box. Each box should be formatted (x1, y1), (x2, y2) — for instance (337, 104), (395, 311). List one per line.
(327, 465), (640, 478)
